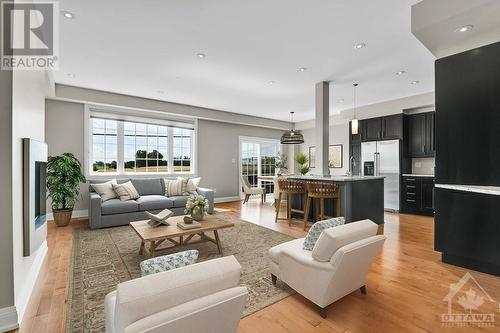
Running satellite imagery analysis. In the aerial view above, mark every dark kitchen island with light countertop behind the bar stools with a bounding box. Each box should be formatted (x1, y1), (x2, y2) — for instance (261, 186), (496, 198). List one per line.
(287, 175), (384, 224)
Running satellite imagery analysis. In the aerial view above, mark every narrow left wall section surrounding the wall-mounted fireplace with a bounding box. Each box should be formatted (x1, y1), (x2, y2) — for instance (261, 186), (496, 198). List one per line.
(12, 71), (48, 322)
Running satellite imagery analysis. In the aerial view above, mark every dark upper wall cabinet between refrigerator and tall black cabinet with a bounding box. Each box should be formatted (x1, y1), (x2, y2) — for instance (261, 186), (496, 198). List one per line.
(406, 112), (436, 157)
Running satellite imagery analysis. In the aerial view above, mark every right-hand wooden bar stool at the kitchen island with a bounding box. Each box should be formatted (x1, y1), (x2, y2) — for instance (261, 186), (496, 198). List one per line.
(304, 182), (340, 230)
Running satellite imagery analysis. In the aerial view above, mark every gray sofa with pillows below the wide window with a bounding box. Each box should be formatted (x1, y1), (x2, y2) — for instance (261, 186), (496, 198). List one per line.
(89, 178), (214, 229)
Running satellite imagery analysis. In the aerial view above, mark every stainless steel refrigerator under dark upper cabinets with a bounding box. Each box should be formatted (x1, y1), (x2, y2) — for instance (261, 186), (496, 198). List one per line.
(361, 140), (400, 211)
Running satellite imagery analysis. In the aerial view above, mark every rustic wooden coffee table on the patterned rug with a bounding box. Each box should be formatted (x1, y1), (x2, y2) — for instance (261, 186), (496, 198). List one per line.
(130, 215), (234, 258)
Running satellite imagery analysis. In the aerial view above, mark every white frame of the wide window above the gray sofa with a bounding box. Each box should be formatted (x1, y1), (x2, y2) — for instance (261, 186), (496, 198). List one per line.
(83, 104), (198, 180)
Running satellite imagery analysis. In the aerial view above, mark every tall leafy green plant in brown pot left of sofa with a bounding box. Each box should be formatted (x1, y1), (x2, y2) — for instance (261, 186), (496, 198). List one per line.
(47, 153), (86, 227)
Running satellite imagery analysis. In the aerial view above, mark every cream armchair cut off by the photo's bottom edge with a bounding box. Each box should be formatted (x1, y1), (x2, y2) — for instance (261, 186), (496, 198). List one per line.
(105, 256), (248, 333)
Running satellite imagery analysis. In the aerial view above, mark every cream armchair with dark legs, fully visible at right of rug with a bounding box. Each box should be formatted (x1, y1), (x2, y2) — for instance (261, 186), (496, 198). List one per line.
(269, 220), (385, 318)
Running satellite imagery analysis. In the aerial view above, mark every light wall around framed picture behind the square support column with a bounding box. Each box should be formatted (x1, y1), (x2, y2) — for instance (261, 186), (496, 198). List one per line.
(299, 124), (349, 175)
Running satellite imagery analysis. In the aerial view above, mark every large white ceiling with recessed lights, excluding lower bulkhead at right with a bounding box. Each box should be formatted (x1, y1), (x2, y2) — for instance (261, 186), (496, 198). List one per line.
(55, 0), (434, 121)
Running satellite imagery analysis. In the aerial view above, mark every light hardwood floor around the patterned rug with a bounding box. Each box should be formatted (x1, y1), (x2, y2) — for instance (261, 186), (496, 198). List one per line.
(15, 199), (500, 333)
